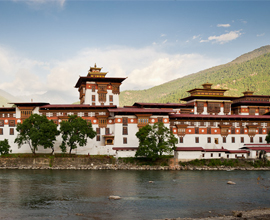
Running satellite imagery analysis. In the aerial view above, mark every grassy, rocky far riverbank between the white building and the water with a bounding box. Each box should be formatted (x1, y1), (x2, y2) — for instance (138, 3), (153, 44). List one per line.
(0, 156), (270, 171)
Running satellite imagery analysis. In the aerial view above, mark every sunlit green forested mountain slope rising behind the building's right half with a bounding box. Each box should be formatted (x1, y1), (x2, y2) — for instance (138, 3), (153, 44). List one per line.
(120, 45), (270, 106)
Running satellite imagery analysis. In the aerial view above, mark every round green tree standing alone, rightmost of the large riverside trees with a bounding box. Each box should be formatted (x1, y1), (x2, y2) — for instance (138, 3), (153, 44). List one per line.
(135, 122), (177, 160)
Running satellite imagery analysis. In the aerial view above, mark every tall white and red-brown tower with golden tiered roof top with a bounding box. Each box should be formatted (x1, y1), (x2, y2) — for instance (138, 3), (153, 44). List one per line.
(75, 64), (126, 106)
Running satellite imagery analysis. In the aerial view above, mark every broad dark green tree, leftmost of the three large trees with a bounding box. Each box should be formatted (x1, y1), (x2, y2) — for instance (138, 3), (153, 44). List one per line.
(14, 114), (60, 154)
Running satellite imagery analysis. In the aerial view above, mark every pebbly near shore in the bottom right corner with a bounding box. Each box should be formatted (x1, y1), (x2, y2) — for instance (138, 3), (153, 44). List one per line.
(160, 208), (270, 220)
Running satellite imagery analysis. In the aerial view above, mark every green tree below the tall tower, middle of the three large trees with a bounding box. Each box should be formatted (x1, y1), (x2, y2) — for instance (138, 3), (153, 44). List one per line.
(60, 115), (96, 154)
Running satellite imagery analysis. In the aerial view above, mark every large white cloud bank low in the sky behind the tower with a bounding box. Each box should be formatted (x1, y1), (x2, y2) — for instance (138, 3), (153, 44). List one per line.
(0, 47), (221, 101)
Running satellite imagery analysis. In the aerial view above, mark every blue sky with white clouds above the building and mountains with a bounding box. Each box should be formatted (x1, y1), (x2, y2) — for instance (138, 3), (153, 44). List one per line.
(0, 0), (270, 101)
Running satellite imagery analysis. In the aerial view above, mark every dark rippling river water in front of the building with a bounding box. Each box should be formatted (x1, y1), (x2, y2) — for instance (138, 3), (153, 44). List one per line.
(0, 170), (270, 220)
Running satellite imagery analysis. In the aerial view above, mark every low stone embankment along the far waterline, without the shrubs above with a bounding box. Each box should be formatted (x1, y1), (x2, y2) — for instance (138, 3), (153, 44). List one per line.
(0, 157), (270, 171)
